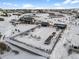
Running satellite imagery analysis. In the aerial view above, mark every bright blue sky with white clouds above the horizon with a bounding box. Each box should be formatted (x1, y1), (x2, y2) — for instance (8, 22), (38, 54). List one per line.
(0, 0), (79, 9)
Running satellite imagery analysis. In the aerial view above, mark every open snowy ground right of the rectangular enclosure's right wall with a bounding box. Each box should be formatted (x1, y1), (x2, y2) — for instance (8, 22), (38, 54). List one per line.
(50, 19), (79, 59)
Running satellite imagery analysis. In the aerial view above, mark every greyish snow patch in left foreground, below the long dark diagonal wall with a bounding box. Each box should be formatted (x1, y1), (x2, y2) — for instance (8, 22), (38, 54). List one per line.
(0, 43), (46, 59)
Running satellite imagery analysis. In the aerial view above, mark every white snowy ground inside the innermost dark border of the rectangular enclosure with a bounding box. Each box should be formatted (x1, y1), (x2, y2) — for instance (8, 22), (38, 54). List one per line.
(14, 27), (61, 50)
